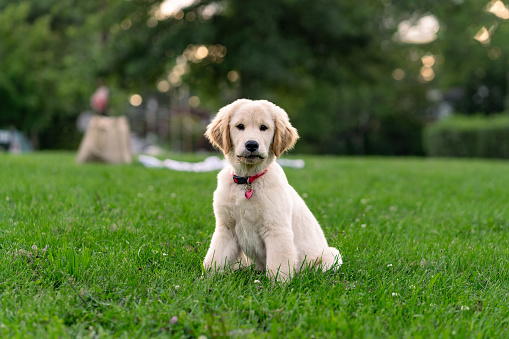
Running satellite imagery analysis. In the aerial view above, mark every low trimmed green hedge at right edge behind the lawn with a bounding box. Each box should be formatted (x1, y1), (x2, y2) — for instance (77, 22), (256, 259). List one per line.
(423, 114), (509, 159)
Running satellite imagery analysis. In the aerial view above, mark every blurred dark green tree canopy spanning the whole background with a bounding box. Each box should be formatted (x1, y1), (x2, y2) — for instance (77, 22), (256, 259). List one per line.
(0, 0), (509, 154)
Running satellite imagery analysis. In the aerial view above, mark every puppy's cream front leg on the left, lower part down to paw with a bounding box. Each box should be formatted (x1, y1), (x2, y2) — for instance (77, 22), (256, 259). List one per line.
(203, 224), (240, 271)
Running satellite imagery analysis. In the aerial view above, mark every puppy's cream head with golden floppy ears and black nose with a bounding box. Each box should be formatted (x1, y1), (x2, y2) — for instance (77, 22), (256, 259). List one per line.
(205, 99), (299, 165)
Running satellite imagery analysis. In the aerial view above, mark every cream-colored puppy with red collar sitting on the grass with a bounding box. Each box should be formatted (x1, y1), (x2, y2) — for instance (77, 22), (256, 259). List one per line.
(203, 99), (342, 280)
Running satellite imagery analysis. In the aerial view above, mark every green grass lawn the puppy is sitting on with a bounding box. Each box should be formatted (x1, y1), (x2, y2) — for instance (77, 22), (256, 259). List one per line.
(0, 153), (509, 338)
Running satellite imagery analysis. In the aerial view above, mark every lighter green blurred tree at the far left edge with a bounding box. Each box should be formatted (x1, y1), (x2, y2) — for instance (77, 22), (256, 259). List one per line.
(0, 1), (98, 146)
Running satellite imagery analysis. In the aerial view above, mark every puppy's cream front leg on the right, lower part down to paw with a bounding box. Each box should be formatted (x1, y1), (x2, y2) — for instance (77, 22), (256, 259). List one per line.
(264, 229), (298, 281)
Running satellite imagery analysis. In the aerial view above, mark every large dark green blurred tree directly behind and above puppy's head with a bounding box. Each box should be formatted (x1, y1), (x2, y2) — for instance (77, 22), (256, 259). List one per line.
(141, 0), (424, 154)
